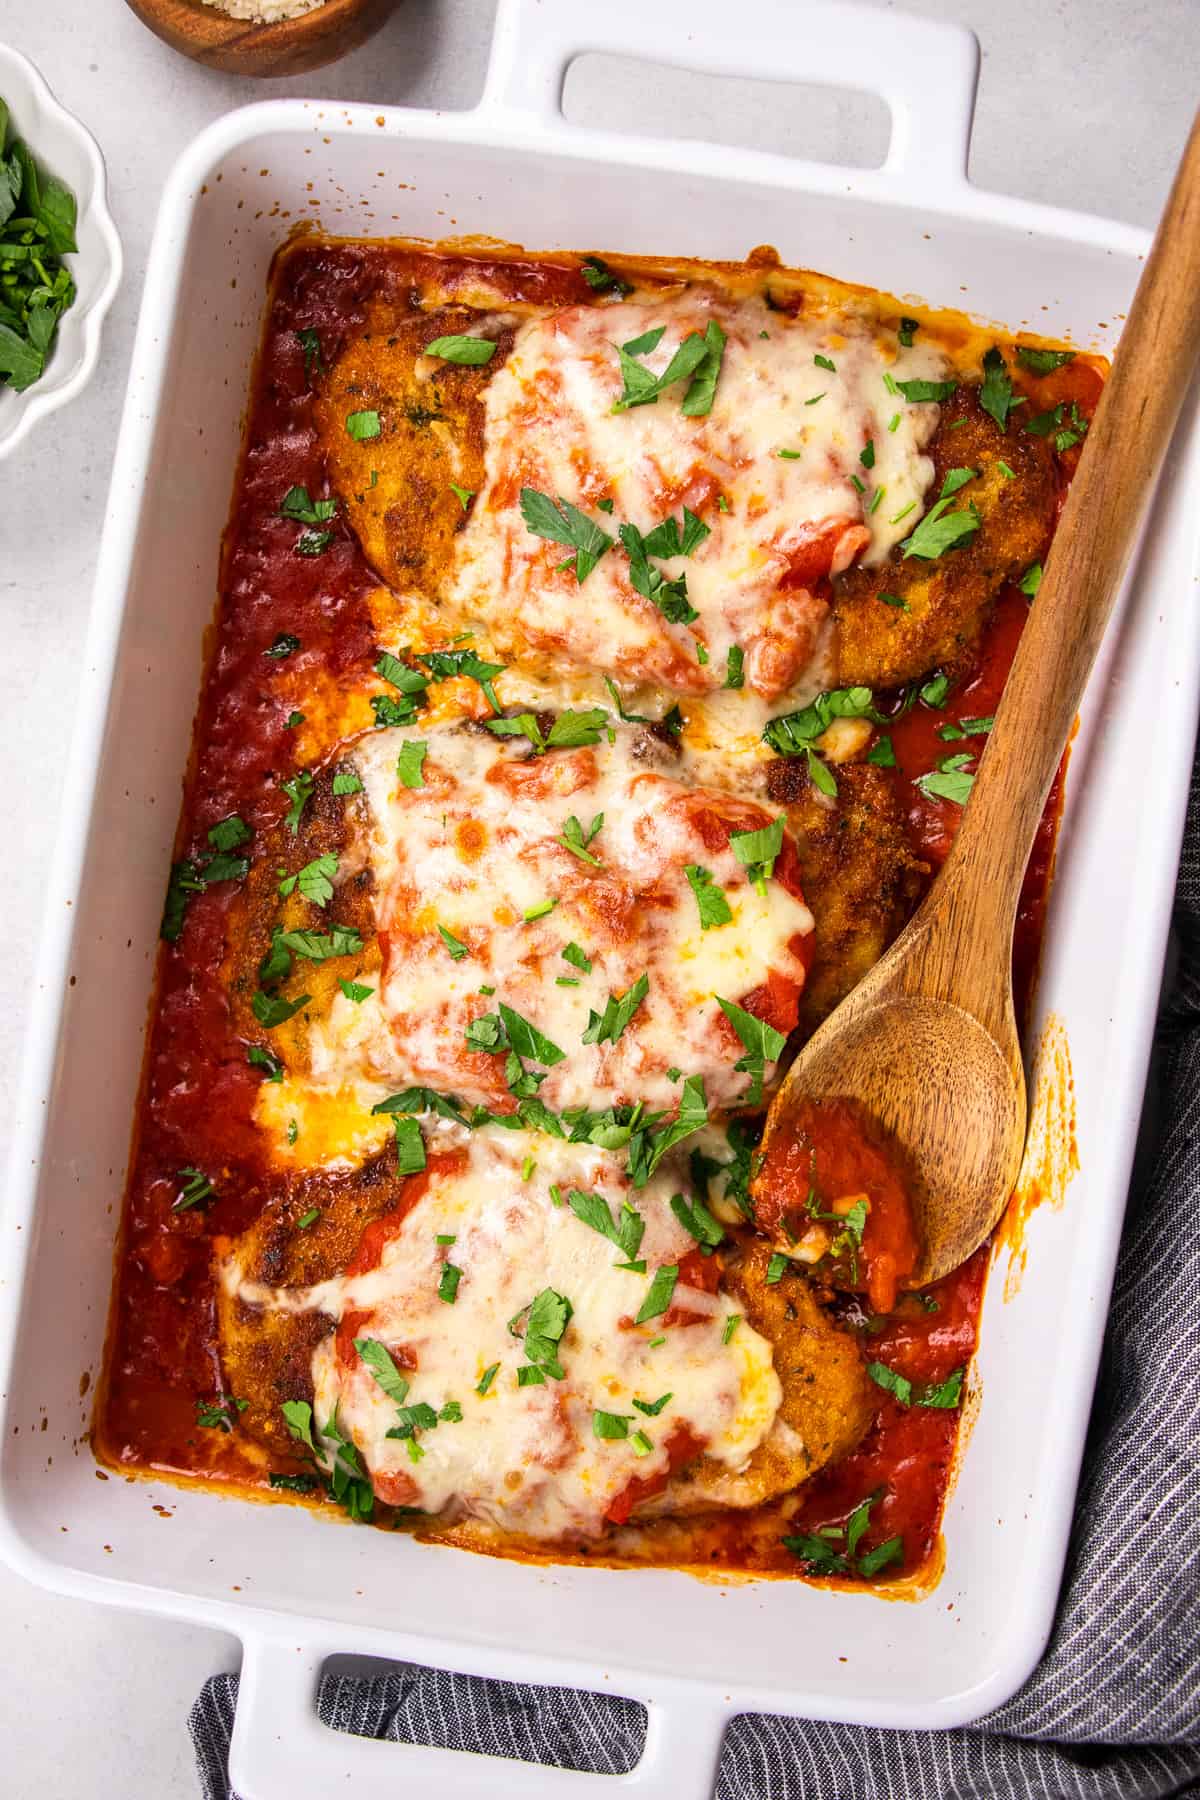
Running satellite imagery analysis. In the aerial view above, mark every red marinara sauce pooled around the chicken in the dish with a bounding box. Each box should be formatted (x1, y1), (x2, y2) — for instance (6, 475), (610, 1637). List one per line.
(95, 241), (1099, 1573)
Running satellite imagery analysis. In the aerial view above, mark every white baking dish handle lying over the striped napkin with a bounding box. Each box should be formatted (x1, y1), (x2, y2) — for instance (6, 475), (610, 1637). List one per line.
(228, 1634), (729, 1800)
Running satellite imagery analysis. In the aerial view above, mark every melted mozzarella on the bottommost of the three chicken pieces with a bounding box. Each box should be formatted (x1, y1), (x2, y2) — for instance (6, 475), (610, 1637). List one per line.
(221, 1127), (781, 1539)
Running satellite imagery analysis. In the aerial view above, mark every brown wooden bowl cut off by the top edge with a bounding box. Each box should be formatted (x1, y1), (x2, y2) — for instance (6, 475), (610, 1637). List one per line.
(126, 0), (398, 76)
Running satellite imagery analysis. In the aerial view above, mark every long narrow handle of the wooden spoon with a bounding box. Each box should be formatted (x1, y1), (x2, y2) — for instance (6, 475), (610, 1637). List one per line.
(930, 113), (1200, 979)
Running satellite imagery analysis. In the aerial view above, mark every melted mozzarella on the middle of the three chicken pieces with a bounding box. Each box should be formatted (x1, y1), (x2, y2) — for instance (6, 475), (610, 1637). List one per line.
(356, 727), (813, 1111)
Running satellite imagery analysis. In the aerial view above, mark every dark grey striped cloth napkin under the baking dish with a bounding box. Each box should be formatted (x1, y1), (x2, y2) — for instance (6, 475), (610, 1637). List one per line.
(189, 765), (1200, 1800)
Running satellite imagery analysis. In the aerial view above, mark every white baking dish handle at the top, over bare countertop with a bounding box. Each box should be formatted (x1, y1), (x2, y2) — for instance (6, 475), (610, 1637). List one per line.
(480, 0), (979, 200)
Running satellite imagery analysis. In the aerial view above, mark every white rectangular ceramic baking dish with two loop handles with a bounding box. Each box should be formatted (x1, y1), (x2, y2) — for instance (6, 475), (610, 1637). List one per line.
(0, 0), (1200, 1800)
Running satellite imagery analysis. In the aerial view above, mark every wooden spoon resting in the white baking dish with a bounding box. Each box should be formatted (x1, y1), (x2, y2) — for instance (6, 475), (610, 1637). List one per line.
(763, 105), (1200, 1285)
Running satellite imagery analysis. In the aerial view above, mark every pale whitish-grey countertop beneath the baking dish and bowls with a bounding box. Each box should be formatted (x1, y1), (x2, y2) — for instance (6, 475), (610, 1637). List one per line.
(0, 0), (1200, 1800)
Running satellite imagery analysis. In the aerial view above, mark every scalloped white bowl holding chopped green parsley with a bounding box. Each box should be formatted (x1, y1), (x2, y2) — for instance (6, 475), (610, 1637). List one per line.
(0, 43), (122, 459)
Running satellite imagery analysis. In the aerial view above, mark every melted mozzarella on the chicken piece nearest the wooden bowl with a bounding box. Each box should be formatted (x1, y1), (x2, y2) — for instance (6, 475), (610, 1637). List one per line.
(452, 286), (945, 698)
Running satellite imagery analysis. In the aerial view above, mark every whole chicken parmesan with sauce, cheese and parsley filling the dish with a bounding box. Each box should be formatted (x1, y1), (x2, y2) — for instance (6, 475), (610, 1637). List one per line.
(95, 238), (1105, 1584)
